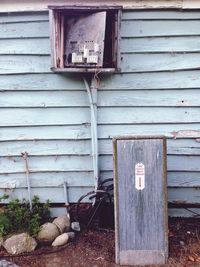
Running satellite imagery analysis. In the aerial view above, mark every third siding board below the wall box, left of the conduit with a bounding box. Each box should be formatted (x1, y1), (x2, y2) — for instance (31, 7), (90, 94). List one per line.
(0, 108), (90, 126)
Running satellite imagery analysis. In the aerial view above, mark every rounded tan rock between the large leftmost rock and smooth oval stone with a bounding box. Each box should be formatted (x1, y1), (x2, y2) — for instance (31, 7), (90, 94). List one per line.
(37, 223), (60, 243)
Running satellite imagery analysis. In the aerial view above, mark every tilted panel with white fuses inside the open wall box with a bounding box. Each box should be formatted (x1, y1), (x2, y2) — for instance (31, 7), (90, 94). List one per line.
(65, 11), (106, 67)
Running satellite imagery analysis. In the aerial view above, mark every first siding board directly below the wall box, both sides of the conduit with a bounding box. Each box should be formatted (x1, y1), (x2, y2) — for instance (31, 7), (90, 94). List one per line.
(0, 71), (200, 91)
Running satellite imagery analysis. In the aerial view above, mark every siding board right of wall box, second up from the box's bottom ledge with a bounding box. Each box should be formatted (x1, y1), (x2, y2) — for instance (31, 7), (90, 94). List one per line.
(121, 36), (200, 53)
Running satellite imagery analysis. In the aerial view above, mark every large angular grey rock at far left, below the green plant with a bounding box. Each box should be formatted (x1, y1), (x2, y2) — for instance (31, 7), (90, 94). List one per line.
(3, 233), (37, 255)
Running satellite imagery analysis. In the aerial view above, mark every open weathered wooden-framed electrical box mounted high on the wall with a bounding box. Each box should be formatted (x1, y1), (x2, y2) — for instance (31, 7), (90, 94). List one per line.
(49, 5), (122, 73)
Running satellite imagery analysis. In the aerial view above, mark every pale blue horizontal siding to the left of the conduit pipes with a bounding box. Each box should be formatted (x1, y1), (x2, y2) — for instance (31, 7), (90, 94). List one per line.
(0, 12), (94, 202)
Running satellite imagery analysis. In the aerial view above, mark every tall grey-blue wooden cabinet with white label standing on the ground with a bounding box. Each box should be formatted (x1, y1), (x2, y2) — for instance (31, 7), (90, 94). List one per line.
(113, 137), (168, 265)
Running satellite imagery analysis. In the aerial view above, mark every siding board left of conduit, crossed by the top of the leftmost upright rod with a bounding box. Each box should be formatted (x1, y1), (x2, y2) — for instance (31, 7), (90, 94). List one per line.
(0, 156), (92, 174)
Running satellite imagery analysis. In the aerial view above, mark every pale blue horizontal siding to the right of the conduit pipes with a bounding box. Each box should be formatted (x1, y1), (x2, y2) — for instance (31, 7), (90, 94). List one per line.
(102, 11), (200, 215)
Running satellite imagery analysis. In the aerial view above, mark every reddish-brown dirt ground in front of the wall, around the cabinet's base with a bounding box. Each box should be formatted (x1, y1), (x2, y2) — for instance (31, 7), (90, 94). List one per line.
(0, 219), (200, 267)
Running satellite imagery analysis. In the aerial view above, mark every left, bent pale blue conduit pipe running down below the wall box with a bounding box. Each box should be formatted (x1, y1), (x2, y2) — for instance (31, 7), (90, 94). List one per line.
(83, 77), (99, 191)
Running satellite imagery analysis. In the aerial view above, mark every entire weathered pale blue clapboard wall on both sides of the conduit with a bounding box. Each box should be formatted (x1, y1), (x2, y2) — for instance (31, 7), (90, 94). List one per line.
(0, 11), (200, 218)
